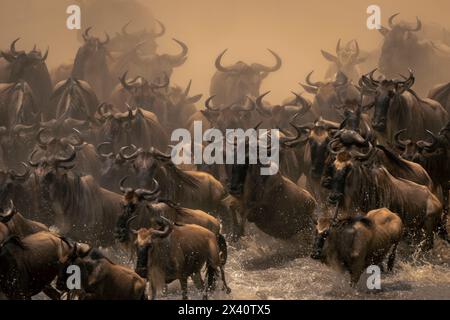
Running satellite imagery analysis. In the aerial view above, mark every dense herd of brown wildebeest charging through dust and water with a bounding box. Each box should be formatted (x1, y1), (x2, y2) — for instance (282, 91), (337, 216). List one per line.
(0, 15), (450, 299)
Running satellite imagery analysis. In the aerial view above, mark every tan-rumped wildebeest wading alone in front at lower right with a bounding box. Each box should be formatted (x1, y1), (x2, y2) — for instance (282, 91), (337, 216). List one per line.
(311, 208), (403, 285)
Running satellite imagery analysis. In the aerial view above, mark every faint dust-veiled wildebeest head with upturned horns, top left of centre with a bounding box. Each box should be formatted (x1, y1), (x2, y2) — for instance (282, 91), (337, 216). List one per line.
(108, 20), (166, 55)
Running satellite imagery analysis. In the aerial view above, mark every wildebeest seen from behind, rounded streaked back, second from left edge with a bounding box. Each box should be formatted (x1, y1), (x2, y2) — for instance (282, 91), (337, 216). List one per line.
(51, 78), (98, 120)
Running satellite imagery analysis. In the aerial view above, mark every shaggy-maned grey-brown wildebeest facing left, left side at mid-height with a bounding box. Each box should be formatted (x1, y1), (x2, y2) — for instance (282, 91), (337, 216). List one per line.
(27, 145), (122, 245)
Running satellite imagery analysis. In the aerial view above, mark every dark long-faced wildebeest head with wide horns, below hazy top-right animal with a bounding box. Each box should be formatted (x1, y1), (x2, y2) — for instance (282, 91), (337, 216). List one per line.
(360, 69), (415, 132)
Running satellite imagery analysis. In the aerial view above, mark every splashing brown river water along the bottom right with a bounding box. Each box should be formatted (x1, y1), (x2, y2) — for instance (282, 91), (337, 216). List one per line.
(108, 225), (450, 300)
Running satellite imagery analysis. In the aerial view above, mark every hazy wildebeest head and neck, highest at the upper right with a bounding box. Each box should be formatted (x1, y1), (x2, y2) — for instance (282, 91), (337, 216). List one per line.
(378, 13), (422, 78)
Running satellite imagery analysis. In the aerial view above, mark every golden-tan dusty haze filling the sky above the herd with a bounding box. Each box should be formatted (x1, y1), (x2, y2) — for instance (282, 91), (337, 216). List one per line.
(0, 0), (450, 101)
